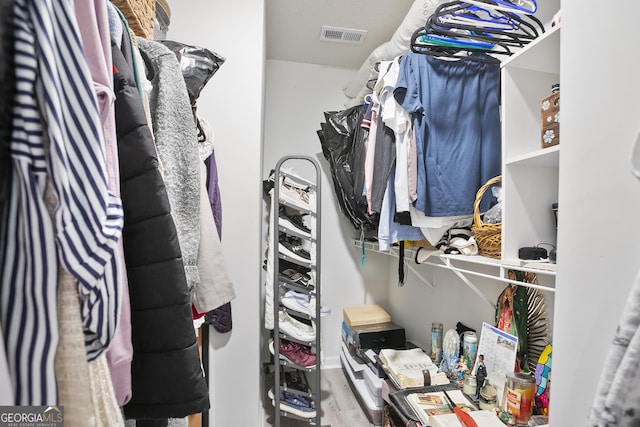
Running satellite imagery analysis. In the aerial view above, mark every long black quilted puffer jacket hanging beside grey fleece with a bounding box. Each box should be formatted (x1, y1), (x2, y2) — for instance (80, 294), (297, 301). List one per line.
(112, 42), (209, 419)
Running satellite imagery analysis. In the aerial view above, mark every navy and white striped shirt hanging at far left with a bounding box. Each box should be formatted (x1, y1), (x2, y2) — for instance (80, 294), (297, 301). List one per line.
(0, 0), (123, 405)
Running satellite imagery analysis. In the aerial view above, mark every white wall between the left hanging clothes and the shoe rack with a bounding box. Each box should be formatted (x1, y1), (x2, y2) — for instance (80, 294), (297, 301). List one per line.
(167, 0), (265, 427)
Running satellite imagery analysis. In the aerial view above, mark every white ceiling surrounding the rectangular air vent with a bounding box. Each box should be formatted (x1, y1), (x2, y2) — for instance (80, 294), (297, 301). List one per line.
(265, 0), (413, 69)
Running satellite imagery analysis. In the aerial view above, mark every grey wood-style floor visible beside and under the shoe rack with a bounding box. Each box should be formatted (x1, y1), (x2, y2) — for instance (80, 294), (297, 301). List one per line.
(263, 368), (374, 427)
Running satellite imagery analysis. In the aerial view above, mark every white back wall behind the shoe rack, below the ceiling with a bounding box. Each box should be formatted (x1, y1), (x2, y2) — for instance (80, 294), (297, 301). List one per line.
(263, 61), (388, 367)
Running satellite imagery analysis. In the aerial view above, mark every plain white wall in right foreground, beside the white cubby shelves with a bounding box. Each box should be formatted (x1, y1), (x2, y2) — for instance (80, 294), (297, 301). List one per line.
(550, 0), (640, 427)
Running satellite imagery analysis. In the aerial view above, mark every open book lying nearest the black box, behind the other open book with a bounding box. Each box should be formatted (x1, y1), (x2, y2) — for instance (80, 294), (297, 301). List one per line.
(378, 348), (449, 388)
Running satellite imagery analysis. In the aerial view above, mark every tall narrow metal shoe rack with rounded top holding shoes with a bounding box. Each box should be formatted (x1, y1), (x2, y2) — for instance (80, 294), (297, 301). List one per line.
(270, 155), (328, 427)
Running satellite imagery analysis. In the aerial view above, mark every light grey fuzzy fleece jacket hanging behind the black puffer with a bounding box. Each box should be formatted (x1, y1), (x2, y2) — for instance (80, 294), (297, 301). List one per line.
(137, 37), (200, 290)
